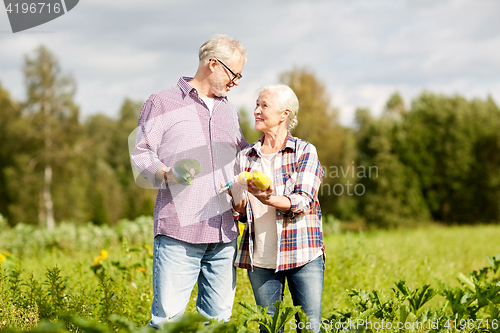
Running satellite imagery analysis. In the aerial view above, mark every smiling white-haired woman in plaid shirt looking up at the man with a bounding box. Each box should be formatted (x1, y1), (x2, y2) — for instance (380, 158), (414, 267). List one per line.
(232, 85), (325, 332)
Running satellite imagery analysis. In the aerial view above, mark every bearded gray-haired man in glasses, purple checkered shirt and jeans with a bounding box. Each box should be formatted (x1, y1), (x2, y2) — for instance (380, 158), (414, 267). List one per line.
(131, 35), (248, 328)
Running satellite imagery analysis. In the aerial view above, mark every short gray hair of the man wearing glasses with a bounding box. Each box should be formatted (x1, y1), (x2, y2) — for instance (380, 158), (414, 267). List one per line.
(198, 35), (247, 64)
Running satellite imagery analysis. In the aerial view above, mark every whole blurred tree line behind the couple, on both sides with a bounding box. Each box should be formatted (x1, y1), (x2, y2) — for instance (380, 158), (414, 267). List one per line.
(0, 46), (500, 229)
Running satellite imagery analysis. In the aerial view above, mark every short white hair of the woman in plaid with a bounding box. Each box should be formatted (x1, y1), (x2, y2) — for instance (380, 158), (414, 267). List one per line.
(257, 84), (299, 131)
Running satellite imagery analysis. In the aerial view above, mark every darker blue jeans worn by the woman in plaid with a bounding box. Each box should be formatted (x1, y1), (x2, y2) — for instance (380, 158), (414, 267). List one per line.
(248, 256), (325, 332)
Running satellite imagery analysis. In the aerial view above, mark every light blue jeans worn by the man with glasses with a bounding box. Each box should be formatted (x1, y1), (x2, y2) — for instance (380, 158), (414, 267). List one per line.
(148, 236), (236, 328)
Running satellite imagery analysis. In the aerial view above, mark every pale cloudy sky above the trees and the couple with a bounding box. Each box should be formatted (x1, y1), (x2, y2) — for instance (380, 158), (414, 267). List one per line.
(0, 0), (500, 126)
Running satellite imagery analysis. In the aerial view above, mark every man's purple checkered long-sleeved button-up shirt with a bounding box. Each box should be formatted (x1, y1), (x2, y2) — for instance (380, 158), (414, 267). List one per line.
(130, 77), (248, 244)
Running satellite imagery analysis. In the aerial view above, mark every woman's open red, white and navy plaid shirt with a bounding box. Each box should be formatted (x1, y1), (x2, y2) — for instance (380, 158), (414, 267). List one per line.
(235, 133), (324, 271)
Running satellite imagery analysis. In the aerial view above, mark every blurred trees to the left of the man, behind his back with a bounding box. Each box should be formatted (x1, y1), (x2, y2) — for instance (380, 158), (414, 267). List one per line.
(0, 46), (155, 229)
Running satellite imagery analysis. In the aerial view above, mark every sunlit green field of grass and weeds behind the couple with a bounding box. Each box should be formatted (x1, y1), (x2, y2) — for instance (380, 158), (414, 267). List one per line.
(0, 218), (500, 328)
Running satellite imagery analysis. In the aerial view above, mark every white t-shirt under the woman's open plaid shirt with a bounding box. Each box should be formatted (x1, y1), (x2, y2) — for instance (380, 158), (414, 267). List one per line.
(252, 152), (278, 269)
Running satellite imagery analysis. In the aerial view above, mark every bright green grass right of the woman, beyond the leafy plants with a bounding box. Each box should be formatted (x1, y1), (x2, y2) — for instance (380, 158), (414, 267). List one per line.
(323, 225), (500, 315)
